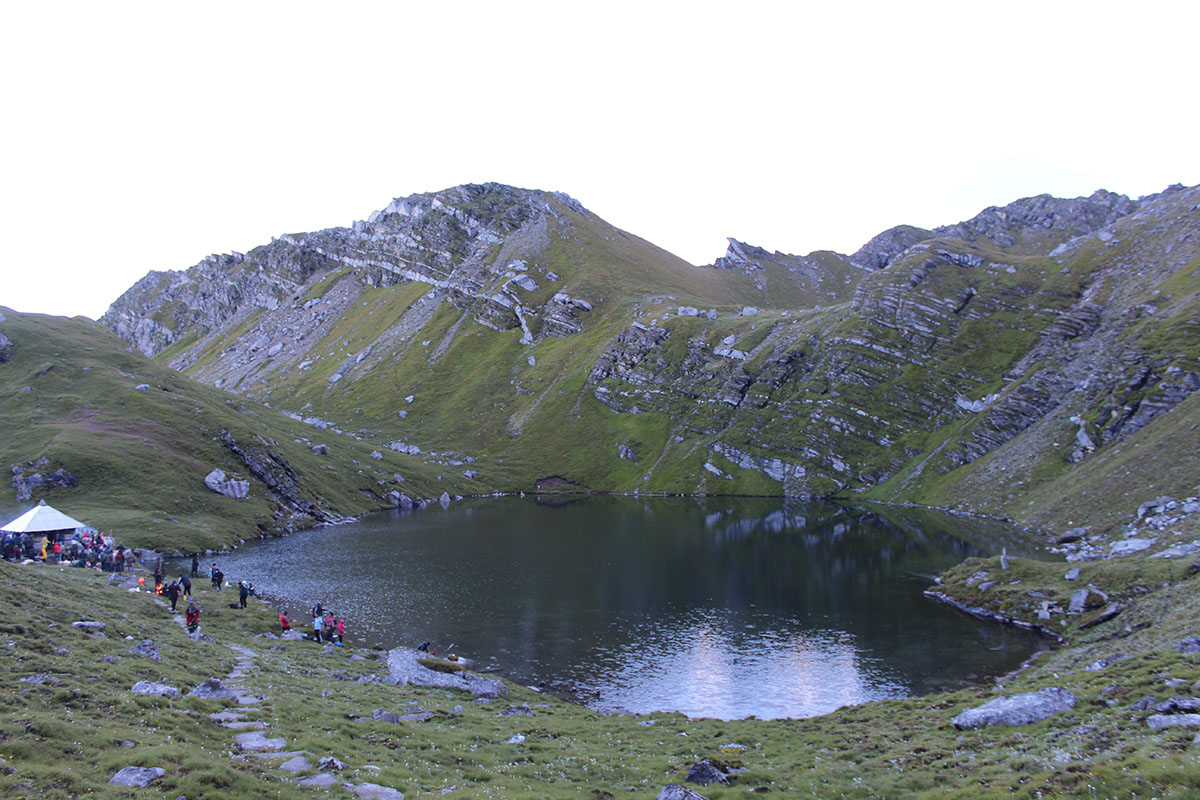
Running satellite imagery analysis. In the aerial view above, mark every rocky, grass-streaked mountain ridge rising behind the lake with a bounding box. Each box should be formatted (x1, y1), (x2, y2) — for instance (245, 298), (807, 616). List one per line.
(102, 179), (1200, 532)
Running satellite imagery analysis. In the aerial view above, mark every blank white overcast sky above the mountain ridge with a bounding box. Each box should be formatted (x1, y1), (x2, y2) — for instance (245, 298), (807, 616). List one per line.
(0, 0), (1200, 317)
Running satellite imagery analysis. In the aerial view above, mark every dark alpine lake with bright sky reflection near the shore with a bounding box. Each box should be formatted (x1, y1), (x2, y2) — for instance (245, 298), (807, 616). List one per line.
(184, 497), (1045, 718)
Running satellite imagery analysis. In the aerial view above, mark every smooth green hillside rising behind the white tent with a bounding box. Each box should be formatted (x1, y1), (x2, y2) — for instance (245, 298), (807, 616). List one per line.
(0, 308), (466, 553)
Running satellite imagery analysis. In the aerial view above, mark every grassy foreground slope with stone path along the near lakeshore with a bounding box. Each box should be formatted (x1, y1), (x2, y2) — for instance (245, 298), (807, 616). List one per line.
(0, 557), (1200, 800)
